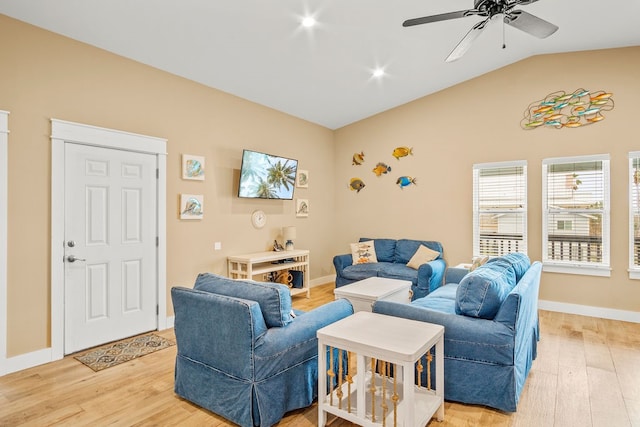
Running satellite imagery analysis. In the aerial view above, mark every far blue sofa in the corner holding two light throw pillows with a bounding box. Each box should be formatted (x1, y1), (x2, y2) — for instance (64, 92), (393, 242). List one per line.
(333, 237), (446, 300)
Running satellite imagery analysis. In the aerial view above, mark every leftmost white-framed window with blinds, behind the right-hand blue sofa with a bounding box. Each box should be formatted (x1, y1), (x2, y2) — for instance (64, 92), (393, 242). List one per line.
(473, 161), (527, 257)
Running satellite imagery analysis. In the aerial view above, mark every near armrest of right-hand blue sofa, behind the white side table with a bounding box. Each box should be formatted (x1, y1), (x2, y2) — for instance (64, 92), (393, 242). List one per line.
(373, 301), (515, 365)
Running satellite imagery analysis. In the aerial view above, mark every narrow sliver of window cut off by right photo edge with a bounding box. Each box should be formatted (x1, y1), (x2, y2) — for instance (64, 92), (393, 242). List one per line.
(629, 151), (640, 279)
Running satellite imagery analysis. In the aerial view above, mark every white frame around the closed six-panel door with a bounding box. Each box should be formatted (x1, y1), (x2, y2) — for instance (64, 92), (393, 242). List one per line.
(51, 119), (167, 360)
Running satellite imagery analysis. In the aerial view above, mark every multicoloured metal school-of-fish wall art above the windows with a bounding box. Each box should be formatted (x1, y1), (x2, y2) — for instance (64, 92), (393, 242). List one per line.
(520, 88), (614, 130)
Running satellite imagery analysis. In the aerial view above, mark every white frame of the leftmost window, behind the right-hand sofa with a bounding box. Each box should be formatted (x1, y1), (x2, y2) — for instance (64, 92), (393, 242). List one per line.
(473, 160), (528, 257)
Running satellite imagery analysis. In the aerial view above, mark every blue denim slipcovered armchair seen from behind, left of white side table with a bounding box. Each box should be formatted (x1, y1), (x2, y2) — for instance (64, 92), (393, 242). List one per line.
(171, 273), (353, 427)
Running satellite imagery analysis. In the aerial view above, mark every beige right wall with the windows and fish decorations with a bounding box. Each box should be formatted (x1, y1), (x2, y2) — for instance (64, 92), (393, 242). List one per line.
(335, 47), (640, 312)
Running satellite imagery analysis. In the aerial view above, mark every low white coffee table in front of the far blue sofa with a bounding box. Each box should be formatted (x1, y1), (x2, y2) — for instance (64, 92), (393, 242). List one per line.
(333, 277), (411, 312)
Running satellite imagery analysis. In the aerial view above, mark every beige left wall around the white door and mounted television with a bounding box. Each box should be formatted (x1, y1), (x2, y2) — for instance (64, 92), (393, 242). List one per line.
(0, 15), (335, 356)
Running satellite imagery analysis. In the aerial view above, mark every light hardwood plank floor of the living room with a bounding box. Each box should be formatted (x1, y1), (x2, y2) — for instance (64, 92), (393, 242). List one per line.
(0, 283), (640, 427)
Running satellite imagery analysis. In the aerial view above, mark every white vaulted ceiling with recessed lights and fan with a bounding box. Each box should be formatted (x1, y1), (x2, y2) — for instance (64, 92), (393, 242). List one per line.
(0, 0), (640, 129)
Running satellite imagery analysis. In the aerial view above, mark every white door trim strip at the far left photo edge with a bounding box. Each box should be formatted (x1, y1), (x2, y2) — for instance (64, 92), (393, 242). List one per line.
(0, 111), (9, 377)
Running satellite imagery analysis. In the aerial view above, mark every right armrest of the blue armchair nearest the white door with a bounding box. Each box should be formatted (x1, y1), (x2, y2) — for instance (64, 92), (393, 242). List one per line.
(256, 299), (353, 364)
